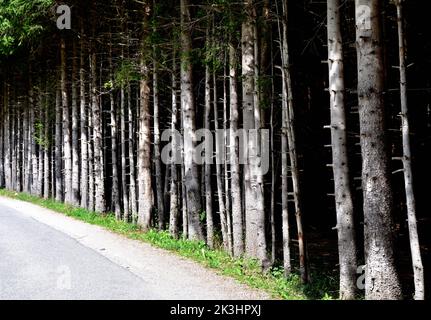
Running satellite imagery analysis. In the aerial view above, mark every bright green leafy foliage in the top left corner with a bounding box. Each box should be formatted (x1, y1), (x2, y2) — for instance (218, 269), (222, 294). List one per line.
(0, 0), (54, 56)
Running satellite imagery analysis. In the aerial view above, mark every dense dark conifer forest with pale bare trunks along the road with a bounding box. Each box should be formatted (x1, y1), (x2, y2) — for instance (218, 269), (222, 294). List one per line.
(0, 0), (431, 300)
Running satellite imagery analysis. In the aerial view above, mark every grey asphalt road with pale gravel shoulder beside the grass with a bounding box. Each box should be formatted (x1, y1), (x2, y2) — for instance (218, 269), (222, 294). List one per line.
(0, 197), (270, 300)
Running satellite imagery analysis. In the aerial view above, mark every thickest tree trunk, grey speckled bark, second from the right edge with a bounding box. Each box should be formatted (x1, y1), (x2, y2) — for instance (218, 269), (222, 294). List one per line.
(355, 0), (402, 300)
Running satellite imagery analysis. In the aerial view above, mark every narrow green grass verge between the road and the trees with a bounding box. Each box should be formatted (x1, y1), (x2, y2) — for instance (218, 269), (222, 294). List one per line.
(0, 189), (336, 300)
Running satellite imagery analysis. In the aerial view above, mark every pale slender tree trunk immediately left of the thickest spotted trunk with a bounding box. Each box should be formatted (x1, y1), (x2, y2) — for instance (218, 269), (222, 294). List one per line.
(328, 0), (358, 300)
